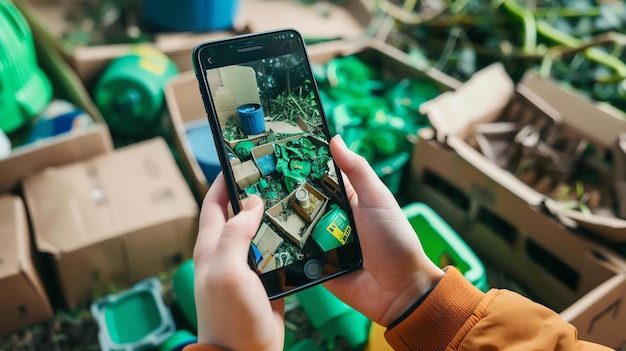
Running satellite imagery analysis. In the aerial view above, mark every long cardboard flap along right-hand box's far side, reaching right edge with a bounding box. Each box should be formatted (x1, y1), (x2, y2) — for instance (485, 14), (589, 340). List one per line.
(519, 71), (626, 148)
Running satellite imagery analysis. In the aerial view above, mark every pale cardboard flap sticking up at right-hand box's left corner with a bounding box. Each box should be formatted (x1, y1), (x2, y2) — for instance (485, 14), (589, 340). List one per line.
(420, 63), (514, 142)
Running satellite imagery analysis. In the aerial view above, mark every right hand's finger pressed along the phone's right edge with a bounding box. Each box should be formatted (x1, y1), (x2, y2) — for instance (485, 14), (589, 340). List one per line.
(330, 135), (391, 204)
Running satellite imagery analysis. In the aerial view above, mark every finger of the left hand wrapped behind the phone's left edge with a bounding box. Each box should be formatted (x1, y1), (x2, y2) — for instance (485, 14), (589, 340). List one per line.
(193, 173), (228, 262)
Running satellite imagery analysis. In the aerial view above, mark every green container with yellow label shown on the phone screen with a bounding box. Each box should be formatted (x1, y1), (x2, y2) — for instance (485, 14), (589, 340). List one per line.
(311, 206), (353, 252)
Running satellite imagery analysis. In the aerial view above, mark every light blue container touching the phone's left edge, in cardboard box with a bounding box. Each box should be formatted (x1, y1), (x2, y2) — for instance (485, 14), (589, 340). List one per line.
(187, 124), (222, 183)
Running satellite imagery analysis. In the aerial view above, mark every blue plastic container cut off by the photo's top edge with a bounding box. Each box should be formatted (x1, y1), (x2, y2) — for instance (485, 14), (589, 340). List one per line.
(143, 0), (239, 32)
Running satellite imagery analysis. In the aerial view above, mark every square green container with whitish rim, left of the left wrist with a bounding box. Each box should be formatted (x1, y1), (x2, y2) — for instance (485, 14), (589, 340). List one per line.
(91, 278), (176, 351)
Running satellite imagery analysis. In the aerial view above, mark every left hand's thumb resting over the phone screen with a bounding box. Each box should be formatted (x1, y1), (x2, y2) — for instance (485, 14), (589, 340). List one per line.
(217, 196), (263, 260)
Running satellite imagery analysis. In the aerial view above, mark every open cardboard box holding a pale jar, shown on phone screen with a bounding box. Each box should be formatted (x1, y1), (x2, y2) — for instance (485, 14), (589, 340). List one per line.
(265, 189), (328, 248)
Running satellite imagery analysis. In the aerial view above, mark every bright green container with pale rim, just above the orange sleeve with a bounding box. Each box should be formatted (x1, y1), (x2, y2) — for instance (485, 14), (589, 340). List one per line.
(402, 202), (489, 291)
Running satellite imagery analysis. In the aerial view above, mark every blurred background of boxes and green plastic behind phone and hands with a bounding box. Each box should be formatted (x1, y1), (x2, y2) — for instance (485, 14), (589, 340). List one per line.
(0, 0), (626, 351)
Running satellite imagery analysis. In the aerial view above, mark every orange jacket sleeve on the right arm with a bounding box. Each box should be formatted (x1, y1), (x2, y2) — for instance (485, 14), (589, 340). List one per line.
(385, 267), (611, 351)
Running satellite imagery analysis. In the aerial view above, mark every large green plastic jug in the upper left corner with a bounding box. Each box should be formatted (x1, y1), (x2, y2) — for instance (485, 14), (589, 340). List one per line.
(0, 0), (52, 134)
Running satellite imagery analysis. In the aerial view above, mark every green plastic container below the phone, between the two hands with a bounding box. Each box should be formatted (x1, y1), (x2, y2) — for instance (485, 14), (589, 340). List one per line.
(296, 284), (371, 349)
